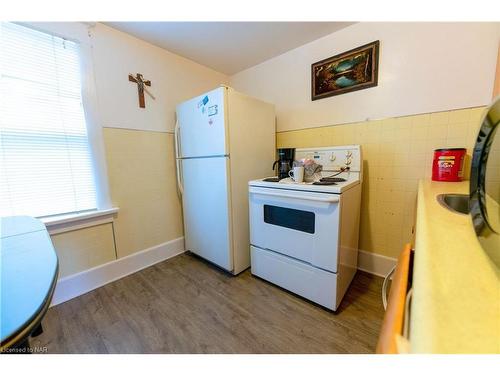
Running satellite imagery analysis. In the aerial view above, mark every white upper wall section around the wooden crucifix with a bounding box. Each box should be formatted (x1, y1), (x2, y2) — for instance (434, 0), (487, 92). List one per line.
(91, 23), (229, 132)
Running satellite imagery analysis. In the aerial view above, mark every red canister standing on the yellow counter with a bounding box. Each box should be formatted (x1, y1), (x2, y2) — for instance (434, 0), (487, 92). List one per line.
(432, 148), (465, 182)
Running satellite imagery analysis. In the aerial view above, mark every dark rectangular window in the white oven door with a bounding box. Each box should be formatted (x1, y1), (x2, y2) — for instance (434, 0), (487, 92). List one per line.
(264, 204), (315, 234)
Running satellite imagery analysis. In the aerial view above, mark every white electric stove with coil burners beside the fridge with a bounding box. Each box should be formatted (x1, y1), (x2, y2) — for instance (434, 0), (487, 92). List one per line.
(249, 145), (363, 310)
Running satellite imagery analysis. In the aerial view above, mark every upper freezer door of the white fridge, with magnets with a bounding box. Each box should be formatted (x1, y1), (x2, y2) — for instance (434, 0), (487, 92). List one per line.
(177, 87), (229, 158)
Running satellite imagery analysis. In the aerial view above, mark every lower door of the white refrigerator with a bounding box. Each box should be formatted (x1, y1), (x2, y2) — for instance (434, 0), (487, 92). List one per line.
(180, 157), (233, 271)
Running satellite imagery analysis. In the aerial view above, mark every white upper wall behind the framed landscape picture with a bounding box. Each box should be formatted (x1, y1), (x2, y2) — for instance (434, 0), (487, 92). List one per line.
(231, 22), (500, 131)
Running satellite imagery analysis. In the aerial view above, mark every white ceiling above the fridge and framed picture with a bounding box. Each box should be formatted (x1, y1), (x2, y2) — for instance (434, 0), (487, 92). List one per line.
(104, 22), (352, 75)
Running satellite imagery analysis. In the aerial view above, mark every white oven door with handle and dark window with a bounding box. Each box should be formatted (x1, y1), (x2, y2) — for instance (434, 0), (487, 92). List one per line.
(249, 186), (341, 272)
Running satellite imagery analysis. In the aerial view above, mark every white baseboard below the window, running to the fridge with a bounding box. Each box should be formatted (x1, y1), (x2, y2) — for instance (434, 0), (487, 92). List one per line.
(51, 237), (184, 306)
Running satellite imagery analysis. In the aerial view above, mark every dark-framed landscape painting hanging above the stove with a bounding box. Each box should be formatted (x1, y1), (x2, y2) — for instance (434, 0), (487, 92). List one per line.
(311, 40), (380, 100)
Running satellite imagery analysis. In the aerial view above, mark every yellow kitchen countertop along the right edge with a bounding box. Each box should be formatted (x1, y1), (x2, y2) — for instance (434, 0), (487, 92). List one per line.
(410, 181), (500, 353)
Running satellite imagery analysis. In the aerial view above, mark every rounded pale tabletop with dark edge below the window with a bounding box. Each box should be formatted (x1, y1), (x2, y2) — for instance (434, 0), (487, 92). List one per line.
(0, 216), (58, 350)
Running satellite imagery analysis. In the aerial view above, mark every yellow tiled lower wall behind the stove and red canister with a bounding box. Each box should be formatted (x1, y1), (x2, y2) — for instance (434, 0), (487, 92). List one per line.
(277, 107), (484, 257)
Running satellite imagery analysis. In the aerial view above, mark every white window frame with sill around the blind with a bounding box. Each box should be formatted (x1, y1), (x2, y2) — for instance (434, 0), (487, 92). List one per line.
(12, 22), (118, 234)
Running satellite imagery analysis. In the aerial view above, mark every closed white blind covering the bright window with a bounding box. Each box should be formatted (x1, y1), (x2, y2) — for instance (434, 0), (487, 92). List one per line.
(0, 22), (96, 217)
